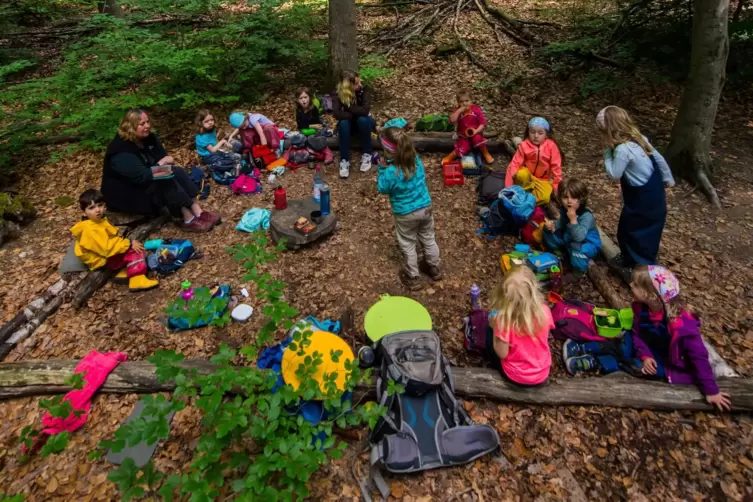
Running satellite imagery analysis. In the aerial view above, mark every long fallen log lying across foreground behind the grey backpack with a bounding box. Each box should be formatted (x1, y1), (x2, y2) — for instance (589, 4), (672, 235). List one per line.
(0, 359), (753, 411)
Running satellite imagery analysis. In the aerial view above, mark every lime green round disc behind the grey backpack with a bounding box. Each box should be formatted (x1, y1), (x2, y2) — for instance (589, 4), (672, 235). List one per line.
(363, 295), (432, 342)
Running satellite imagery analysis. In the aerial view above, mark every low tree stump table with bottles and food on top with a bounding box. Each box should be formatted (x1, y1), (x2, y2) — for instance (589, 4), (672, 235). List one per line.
(269, 197), (337, 250)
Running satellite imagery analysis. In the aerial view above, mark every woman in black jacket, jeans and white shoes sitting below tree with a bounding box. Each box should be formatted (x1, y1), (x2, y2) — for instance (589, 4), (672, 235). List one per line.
(332, 70), (376, 178)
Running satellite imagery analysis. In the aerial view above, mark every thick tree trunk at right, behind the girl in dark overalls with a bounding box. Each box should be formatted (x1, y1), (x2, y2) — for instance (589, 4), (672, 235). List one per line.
(666, 0), (729, 208)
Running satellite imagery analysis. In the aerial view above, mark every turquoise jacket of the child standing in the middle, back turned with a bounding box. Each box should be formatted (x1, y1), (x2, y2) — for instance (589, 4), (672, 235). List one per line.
(377, 155), (431, 215)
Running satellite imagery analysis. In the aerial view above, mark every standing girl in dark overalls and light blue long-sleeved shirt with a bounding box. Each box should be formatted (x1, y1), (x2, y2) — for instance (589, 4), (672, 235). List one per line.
(596, 106), (675, 268)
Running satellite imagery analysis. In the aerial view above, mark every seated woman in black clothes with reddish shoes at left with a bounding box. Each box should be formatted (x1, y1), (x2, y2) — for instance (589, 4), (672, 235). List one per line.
(101, 109), (221, 232)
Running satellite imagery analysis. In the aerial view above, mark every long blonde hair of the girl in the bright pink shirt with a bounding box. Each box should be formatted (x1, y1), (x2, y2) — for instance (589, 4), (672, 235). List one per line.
(492, 266), (547, 337)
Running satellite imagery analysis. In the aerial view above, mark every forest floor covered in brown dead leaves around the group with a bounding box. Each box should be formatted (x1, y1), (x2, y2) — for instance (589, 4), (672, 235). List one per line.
(0, 0), (753, 502)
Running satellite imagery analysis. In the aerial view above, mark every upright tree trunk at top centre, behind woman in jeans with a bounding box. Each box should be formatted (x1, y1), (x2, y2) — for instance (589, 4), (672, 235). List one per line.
(327, 0), (358, 89)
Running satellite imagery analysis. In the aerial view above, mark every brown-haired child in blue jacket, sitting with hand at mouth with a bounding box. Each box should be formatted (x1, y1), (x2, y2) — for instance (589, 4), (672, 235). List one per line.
(544, 178), (601, 275)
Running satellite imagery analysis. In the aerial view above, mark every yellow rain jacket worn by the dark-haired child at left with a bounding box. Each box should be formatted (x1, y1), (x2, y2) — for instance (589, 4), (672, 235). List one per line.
(71, 218), (131, 270)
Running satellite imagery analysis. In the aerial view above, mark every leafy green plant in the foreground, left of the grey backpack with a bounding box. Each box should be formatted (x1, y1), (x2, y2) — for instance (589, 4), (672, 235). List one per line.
(86, 231), (383, 502)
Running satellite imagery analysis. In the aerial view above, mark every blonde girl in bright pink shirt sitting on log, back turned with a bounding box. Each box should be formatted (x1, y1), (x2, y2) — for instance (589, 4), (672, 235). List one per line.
(486, 267), (554, 387)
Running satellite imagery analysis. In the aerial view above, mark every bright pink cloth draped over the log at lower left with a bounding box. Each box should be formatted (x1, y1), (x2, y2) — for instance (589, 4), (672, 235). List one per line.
(42, 350), (128, 435)
